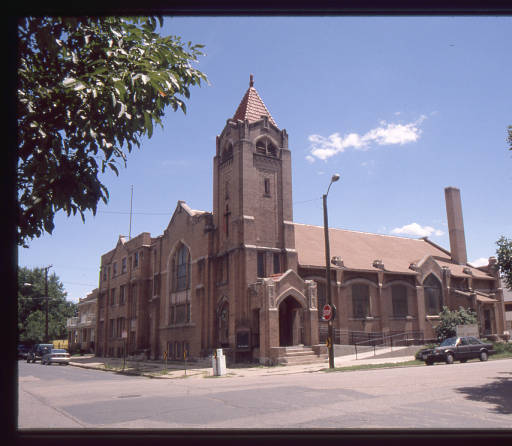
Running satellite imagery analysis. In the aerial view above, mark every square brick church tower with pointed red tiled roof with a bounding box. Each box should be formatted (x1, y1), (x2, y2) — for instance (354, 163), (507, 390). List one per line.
(213, 75), (297, 354)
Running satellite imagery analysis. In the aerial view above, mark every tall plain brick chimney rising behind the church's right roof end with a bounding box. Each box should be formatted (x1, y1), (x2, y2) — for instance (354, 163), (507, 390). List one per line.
(444, 187), (468, 265)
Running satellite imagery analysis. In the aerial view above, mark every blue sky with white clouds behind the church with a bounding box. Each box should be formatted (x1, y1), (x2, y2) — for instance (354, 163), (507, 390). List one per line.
(18, 17), (512, 301)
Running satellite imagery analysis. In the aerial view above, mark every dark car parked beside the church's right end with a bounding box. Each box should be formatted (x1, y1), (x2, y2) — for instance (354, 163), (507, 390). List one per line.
(416, 336), (495, 365)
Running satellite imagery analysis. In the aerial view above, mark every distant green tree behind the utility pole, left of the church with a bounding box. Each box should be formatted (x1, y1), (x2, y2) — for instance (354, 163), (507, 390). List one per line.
(18, 267), (77, 343)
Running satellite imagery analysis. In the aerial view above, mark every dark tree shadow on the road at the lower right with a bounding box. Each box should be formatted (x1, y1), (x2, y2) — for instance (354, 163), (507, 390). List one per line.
(456, 372), (512, 415)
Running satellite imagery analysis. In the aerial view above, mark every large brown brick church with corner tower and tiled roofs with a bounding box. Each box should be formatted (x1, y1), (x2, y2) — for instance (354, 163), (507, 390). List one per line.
(96, 76), (504, 364)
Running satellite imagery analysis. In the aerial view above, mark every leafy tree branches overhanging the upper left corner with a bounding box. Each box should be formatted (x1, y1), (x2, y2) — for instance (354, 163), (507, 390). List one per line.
(17, 17), (207, 246)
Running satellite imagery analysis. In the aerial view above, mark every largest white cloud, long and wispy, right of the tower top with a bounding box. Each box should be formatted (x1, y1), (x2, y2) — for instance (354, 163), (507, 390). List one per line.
(306, 115), (427, 162)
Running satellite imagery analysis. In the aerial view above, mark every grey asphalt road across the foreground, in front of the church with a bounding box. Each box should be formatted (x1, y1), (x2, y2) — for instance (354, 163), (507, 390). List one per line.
(18, 359), (512, 430)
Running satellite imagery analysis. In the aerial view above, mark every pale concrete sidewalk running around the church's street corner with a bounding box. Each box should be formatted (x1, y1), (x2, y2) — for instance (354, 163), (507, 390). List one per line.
(70, 352), (420, 379)
